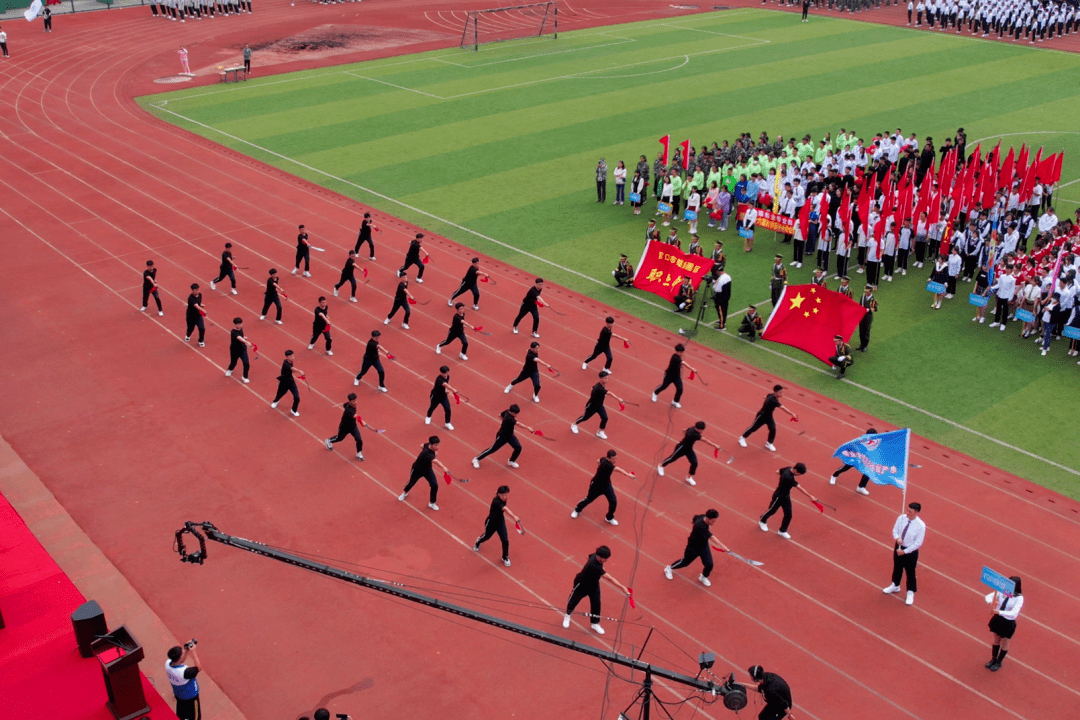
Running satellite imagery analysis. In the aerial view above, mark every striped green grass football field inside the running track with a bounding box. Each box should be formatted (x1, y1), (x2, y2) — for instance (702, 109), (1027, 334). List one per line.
(140, 10), (1080, 498)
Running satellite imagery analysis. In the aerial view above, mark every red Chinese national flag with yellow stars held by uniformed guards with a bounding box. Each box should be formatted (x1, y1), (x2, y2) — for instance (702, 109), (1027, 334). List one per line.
(761, 285), (866, 364)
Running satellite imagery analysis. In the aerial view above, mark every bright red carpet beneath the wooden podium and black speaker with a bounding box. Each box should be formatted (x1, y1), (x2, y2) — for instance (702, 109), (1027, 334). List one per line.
(0, 495), (176, 720)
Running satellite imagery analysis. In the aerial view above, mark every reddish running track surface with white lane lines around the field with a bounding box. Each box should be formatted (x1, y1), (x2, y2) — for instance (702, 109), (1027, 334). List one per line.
(0, 0), (1080, 719)
